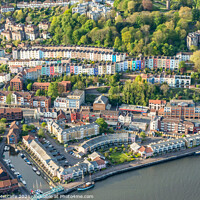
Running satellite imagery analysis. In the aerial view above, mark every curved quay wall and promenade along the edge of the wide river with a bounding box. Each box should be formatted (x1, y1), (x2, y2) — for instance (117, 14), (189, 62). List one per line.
(60, 147), (200, 195)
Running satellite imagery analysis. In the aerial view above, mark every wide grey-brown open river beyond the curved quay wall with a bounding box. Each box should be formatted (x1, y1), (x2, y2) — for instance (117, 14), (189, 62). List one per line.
(69, 156), (200, 200)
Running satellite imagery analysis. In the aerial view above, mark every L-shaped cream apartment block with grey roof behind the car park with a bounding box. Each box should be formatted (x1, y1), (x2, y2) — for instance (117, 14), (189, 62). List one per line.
(47, 121), (99, 143)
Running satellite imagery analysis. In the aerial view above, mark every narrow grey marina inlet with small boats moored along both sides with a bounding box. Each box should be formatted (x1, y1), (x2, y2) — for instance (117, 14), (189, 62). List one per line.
(4, 151), (50, 192)
